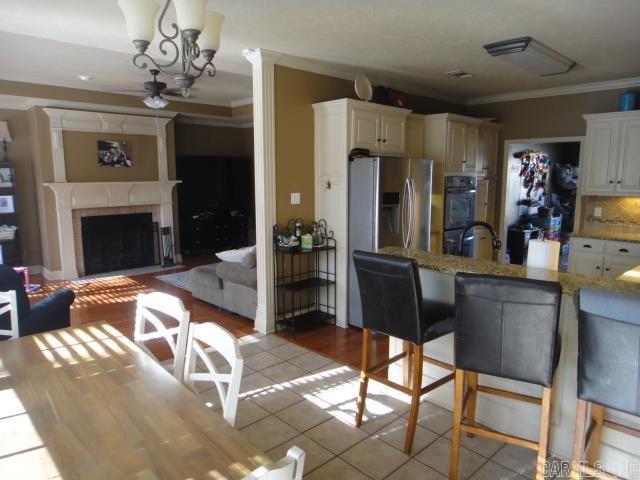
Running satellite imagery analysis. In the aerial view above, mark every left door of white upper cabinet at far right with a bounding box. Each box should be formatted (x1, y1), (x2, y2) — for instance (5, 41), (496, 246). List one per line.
(582, 121), (620, 195)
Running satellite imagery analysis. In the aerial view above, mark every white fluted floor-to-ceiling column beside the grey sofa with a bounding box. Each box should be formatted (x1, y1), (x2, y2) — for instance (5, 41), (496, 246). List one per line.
(242, 49), (282, 333)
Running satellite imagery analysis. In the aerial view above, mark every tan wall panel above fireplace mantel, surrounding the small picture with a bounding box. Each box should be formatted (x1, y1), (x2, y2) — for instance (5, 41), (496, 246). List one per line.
(62, 131), (158, 182)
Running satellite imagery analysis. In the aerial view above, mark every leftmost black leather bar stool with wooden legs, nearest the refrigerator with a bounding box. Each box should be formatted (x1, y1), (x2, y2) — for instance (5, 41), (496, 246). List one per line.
(353, 250), (454, 454)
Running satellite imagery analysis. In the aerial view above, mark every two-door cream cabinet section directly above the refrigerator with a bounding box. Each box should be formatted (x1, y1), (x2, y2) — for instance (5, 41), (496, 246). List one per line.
(348, 100), (410, 156)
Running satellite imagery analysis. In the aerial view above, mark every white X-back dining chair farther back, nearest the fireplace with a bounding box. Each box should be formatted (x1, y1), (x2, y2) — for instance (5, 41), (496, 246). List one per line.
(133, 292), (189, 382)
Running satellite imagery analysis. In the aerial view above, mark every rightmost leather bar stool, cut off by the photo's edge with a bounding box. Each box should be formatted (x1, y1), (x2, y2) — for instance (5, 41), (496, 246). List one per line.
(571, 288), (640, 479)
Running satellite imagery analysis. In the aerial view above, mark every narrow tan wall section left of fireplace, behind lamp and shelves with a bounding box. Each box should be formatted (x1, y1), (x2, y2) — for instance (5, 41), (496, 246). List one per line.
(0, 109), (42, 265)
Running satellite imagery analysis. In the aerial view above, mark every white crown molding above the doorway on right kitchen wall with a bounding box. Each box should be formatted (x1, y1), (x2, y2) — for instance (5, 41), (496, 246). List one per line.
(467, 77), (640, 105)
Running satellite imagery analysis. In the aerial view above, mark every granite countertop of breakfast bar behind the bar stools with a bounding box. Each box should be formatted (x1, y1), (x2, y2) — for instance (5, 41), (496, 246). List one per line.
(378, 247), (640, 295)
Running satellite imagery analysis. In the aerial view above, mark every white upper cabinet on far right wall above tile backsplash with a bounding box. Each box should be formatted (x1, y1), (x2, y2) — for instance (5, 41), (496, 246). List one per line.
(580, 111), (640, 195)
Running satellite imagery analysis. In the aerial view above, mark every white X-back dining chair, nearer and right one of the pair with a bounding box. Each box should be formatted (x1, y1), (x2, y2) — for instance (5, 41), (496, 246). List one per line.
(183, 322), (244, 426)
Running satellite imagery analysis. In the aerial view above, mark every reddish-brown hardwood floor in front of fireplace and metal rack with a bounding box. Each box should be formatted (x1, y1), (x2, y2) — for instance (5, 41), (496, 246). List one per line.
(29, 256), (389, 368)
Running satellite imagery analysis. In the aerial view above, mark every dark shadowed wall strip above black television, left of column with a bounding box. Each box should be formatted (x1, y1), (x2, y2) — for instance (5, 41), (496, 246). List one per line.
(175, 123), (253, 157)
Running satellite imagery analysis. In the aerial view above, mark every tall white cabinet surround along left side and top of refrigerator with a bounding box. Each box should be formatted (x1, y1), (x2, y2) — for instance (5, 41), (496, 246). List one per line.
(313, 99), (411, 327)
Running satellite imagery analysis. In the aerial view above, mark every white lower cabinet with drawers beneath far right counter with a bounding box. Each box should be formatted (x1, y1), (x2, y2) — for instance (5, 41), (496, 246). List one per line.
(569, 237), (640, 278)
